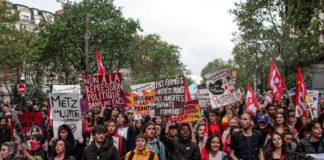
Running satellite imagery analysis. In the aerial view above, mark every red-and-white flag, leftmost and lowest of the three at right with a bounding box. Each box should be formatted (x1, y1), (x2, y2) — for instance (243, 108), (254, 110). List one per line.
(245, 84), (259, 115)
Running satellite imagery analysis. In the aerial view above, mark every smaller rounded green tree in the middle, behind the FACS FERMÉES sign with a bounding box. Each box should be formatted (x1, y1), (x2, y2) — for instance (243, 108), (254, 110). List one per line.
(131, 34), (190, 83)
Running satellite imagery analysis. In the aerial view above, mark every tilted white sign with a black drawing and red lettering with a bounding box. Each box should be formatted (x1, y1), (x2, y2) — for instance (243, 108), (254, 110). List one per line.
(205, 70), (236, 108)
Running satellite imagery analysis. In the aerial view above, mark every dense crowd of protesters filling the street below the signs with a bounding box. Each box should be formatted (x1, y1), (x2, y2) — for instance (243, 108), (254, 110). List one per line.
(0, 92), (324, 160)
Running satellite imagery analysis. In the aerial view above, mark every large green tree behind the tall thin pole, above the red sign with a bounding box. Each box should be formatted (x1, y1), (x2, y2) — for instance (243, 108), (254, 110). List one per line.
(40, 0), (140, 84)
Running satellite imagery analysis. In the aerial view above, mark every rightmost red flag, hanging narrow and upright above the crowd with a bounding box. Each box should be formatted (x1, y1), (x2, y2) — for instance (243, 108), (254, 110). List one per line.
(294, 67), (308, 117)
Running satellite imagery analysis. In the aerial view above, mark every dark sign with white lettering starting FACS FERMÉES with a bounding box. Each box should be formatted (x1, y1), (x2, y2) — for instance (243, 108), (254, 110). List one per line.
(155, 76), (185, 116)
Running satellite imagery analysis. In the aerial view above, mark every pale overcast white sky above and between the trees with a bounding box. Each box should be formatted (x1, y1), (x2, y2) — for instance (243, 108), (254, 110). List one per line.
(9, 0), (237, 83)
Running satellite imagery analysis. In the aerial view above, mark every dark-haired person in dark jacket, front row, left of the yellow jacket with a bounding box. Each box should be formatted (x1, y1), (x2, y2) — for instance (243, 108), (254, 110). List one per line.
(82, 125), (121, 160)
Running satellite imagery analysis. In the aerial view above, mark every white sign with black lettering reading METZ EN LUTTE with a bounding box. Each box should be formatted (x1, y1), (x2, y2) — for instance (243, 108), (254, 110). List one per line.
(49, 93), (82, 121)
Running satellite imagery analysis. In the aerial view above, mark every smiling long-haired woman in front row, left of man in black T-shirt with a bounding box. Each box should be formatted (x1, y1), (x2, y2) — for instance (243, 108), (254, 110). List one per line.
(201, 134), (228, 160)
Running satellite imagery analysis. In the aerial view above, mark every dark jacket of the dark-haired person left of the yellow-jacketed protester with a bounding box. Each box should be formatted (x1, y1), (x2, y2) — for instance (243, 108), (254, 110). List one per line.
(82, 140), (121, 160)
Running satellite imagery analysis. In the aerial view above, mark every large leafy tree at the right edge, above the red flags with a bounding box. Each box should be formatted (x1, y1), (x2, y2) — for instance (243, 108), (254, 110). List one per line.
(231, 0), (323, 91)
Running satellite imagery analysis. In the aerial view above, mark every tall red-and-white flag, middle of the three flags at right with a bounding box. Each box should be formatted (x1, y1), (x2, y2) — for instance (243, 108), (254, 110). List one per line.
(268, 58), (285, 102)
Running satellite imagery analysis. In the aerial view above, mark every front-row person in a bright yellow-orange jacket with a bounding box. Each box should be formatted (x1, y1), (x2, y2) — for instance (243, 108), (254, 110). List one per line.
(124, 134), (159, 160)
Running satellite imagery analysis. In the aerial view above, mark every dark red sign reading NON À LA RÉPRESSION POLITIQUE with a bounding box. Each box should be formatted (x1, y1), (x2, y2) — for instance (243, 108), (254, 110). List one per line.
(82, 73), (125, 108)
